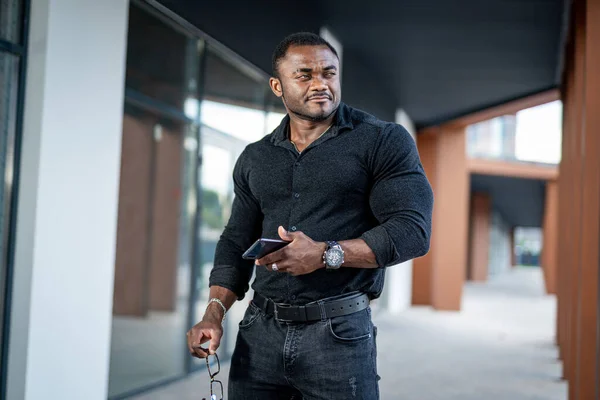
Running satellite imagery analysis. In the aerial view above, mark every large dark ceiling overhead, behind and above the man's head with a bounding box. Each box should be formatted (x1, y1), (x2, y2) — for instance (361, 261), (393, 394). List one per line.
(160, 0), (565, 128)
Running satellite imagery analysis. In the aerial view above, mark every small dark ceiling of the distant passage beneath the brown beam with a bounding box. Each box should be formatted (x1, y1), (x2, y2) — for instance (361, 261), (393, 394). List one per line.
(471, 174), (546, 228)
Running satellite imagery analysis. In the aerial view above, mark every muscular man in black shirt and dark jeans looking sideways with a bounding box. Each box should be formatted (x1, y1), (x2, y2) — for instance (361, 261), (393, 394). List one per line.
(188, 33), (433, 400)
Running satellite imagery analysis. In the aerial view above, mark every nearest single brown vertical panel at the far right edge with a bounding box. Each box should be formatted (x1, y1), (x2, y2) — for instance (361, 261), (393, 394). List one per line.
(572, 0), (600, 399)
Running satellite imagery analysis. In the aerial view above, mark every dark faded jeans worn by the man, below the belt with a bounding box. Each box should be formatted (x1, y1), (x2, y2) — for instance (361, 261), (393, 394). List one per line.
(228, 296), (379, 400)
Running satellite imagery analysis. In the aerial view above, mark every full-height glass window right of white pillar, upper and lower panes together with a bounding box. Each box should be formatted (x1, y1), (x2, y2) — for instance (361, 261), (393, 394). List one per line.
(109, 5), (201, 397)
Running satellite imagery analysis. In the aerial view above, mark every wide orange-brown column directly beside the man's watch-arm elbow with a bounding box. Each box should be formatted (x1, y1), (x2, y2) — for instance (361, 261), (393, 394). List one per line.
(413, 127), (469, 311)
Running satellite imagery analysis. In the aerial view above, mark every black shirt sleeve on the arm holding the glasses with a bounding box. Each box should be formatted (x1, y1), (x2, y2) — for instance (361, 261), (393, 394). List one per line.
(209, 152), (263, 300)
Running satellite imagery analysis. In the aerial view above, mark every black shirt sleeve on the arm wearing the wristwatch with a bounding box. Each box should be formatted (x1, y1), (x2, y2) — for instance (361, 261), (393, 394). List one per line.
(361, 124), (433, 267)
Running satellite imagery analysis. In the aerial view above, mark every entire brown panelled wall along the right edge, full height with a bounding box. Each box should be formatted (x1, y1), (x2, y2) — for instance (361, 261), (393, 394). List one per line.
(557, 0), (600, 400)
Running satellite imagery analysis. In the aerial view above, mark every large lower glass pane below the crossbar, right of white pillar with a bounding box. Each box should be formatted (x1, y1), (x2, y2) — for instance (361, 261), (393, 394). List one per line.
(109, 102), (197, 396)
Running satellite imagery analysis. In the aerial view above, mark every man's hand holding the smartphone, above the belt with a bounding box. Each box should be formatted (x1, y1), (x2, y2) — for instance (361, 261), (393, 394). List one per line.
(256, 226), (327, 276)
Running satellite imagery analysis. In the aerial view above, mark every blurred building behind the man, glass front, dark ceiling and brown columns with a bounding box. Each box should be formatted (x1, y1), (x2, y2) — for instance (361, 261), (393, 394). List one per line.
(0, 0), (600, 400)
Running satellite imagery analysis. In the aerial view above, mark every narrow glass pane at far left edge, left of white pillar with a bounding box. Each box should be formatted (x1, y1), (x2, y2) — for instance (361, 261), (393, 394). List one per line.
(0, 53), (19, 374)
